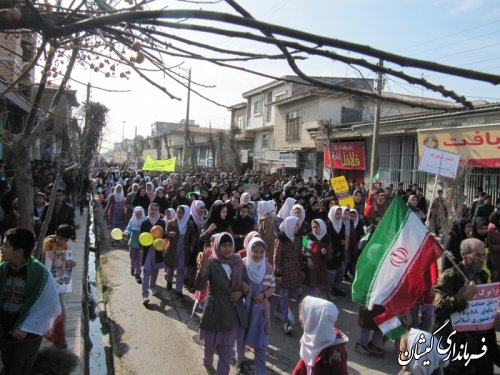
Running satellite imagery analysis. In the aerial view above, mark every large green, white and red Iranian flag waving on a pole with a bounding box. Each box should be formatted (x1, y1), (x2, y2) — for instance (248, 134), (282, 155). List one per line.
(352, 196), (443, 315)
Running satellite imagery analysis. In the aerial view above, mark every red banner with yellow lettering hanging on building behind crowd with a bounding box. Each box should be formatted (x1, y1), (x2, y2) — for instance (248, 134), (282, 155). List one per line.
(324, 142), (366, 171)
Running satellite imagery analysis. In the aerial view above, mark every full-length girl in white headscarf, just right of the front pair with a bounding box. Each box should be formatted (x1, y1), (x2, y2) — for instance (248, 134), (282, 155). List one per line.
(274, 216), (303, 333)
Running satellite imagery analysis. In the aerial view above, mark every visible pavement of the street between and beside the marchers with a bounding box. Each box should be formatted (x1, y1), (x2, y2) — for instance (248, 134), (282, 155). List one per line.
(101, 247), (406, 374)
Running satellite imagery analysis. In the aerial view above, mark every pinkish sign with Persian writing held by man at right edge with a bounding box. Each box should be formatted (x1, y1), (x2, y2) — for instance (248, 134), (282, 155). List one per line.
(450, 283), (500, 331)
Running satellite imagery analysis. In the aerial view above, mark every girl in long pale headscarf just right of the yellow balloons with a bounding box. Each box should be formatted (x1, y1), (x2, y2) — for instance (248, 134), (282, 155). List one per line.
(164, 205), (195, 299)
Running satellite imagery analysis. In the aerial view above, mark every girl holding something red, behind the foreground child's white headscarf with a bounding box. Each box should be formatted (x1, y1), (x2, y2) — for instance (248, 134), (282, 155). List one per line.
(304, 219), (333, 297)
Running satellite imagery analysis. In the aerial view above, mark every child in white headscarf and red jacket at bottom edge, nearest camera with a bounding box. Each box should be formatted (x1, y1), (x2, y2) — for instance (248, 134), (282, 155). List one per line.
(292, 296), (349, 375)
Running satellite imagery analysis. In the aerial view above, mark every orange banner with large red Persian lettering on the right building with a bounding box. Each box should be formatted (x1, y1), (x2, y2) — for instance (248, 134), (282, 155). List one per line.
(418, 124), (500, 168)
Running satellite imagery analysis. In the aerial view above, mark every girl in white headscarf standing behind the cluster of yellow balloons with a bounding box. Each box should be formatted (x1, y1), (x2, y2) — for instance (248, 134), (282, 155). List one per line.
(139, 203), (165, 307)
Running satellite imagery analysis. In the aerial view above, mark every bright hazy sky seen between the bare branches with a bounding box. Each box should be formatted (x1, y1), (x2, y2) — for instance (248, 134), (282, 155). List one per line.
(67, 0), (500, 145)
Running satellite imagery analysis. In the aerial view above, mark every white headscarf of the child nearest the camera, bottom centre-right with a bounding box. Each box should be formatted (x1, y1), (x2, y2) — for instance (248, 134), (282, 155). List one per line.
(300, 296), (339, 366)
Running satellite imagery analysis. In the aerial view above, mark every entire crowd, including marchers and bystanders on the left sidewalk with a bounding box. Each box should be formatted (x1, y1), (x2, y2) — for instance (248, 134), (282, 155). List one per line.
(0, 165), (500, 374)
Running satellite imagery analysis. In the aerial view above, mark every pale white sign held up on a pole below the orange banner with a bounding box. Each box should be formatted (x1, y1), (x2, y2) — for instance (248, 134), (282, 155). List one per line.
(418, 146), (460, 178)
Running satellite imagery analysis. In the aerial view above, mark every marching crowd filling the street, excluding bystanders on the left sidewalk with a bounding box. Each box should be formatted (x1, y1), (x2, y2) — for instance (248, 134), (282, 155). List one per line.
(94, 170), (500, 374)
